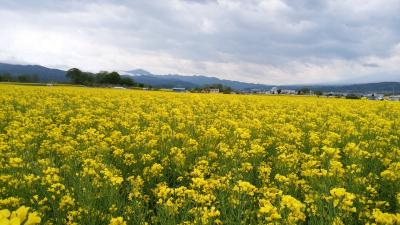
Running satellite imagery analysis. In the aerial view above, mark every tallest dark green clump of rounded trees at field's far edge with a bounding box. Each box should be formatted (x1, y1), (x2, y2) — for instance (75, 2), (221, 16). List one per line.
(66, 68), (151, 88)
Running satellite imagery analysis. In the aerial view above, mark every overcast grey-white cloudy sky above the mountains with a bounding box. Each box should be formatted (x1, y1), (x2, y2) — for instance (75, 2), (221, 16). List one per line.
(0, 0), (400, 84)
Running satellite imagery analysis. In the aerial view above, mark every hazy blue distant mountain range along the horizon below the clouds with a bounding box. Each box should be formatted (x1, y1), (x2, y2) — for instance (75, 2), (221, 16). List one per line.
(0, 63), (400, 94)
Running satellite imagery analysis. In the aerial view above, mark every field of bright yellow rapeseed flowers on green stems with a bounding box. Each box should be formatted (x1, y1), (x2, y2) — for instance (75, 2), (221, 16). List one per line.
(0, 84), (400, 225)
